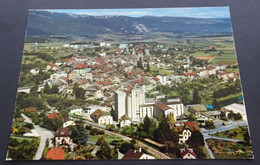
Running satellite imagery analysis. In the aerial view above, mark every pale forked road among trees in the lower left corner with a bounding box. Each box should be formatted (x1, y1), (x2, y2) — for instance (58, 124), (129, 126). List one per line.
(21, 114), (54, 160)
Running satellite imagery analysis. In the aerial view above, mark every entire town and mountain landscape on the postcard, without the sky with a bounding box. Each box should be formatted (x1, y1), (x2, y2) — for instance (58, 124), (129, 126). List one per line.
(6, 7), (253, 160)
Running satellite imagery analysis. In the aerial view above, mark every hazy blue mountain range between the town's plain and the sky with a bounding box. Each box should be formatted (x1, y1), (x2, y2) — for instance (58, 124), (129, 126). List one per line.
(27, 11), (232, 36)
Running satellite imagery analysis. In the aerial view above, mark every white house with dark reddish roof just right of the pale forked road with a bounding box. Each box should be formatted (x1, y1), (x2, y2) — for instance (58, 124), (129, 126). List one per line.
(54, 127), (72, 146)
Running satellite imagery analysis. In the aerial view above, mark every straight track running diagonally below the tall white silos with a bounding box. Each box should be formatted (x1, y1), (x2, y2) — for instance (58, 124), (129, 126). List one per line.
(71, 118), (172, 159)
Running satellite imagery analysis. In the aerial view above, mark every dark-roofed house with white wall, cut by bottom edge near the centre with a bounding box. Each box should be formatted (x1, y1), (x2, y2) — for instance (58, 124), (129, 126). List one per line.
(122, 148), (155, 160)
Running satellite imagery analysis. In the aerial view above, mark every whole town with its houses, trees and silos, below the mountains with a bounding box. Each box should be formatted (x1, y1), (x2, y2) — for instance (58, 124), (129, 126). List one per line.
(7, 38), (252, 160)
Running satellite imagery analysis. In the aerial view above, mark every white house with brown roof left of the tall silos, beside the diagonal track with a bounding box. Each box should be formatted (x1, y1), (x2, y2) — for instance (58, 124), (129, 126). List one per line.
(90, 109), (113, 125)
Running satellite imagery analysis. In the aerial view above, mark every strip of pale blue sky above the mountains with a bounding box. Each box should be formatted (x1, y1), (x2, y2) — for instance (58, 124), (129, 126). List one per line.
(35, 7), (230, 18)
